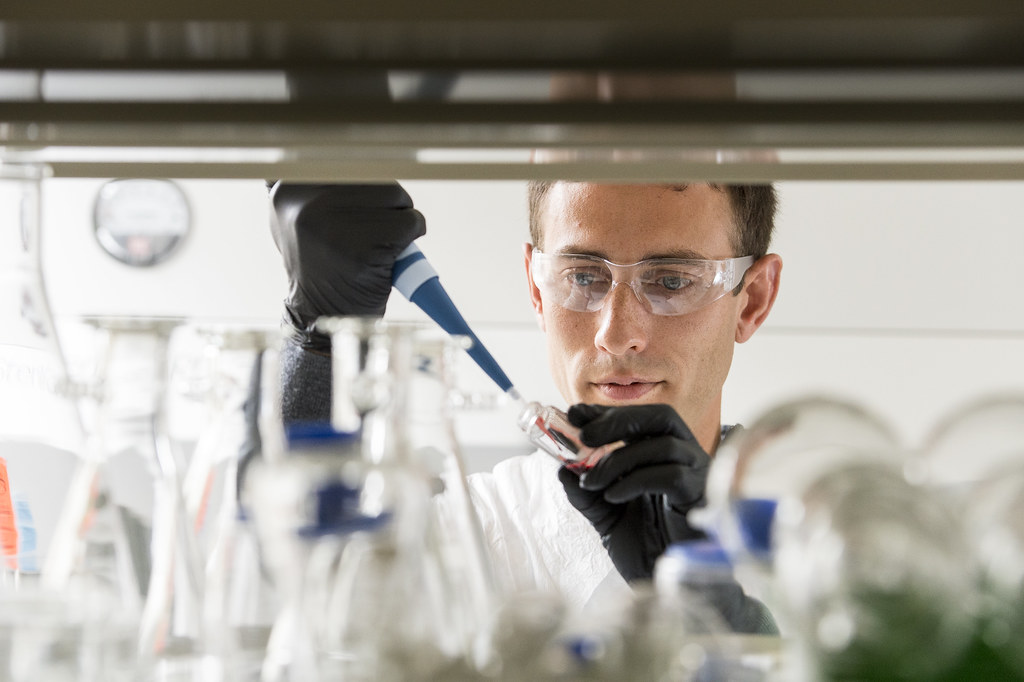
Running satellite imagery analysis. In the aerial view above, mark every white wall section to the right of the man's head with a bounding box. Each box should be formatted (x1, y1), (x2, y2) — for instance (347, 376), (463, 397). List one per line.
(724, 182), (1024, 446)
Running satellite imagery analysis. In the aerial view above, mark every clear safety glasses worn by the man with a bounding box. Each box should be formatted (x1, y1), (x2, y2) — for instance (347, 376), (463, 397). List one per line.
(530, 249), (754, 315)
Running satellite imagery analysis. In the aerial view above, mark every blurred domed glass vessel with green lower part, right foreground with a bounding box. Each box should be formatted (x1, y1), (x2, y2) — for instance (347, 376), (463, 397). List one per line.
(774, 461), (976, 682)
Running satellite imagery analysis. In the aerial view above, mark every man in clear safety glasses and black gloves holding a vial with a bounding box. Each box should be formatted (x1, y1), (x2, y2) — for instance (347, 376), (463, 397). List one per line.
(274, 182), (781, 631)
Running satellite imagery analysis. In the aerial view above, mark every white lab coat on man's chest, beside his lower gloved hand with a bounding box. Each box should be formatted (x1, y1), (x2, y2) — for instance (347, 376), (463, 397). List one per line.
(468, 451), (630, 610)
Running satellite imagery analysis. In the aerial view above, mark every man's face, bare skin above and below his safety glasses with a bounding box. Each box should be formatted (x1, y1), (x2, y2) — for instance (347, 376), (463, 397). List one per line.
(526, 182), (746, 446)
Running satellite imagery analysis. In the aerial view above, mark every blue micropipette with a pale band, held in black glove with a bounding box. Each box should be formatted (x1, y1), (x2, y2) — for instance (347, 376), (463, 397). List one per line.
(391, 244), (522, 401)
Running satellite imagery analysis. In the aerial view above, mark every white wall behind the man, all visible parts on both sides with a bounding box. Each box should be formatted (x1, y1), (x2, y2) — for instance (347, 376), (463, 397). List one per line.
(44, 179), (1024, 467)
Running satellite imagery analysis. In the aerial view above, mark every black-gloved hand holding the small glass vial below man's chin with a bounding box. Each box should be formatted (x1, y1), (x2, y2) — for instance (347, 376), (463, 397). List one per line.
(558, 404), (711, 582)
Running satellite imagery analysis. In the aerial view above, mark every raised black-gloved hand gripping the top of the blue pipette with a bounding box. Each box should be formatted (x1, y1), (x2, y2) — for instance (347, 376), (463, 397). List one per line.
(270, 181), (426, 352)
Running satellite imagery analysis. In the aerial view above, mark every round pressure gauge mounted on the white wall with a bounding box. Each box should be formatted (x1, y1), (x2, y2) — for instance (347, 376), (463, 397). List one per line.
(93, 179), (191, 266)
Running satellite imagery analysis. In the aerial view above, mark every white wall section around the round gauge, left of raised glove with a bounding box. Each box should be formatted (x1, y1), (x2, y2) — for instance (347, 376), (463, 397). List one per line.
(42, 178), (285, 324)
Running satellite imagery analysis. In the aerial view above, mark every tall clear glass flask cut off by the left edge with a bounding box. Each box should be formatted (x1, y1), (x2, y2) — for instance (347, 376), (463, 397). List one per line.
(0, 163), (82, 579)
